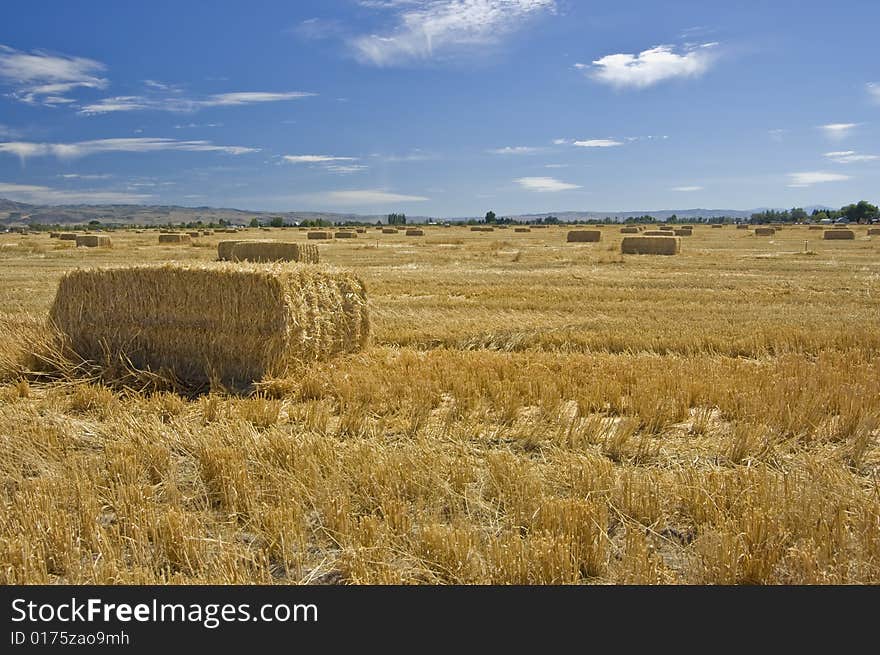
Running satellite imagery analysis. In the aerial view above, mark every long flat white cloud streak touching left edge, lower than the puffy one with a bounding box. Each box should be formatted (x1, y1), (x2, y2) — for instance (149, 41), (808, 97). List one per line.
(0, 137), (259, 159)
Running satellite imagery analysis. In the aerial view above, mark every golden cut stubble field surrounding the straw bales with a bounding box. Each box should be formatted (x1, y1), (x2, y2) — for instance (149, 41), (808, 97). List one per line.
(0, 226), (880, 584)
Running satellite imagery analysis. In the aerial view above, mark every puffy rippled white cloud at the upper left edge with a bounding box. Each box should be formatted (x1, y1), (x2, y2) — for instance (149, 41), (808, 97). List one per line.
(0, 45), (107, 106)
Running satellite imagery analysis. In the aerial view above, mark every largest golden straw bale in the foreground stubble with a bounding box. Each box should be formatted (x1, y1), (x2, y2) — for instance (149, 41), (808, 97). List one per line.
(50, 263), (370, 386)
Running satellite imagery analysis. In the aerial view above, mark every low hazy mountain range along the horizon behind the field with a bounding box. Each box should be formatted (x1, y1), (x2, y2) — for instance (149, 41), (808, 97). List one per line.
(0, 198), (830, 225)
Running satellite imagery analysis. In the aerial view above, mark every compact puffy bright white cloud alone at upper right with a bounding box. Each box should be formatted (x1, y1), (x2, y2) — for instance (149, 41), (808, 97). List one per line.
(575, 43), (718, 89)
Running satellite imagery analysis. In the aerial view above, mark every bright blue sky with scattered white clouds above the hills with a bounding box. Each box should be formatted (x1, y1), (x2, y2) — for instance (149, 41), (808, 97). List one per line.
(0, 0), (880, 216)
